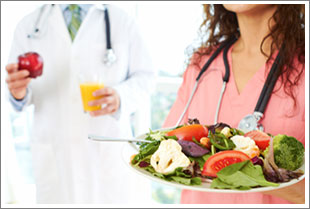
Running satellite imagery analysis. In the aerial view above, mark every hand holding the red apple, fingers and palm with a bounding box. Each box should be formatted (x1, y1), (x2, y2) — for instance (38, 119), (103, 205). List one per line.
(5, 63), (31, 99)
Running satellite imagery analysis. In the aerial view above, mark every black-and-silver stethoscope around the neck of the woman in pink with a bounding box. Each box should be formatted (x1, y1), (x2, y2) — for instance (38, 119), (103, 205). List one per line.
(176, 36), (281, 133)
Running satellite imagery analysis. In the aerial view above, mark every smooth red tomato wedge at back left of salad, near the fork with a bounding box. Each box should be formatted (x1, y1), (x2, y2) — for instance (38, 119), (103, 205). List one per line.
(167, 124), (208, 142)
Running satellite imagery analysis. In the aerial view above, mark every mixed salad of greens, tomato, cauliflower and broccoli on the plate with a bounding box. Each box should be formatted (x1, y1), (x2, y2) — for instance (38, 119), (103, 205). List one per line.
(130, 119), (305, 190)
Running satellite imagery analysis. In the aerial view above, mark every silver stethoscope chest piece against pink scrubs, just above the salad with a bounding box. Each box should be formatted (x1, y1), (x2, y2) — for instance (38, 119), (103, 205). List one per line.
(238, 112), (264, 133)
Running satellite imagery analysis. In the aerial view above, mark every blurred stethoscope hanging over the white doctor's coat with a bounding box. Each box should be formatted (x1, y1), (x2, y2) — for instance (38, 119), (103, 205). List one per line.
(27, 4), (116, 67)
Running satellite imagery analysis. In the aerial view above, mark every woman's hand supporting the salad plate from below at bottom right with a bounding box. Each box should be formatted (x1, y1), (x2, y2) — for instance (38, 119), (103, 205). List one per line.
(263, 179), (305, 204)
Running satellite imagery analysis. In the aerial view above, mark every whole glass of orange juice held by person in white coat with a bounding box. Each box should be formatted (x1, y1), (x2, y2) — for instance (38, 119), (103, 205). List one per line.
(79, 74), (104, 112)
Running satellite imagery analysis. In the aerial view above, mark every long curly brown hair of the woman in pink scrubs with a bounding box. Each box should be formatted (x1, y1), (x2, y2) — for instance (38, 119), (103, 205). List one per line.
(193, 4), (305, 105)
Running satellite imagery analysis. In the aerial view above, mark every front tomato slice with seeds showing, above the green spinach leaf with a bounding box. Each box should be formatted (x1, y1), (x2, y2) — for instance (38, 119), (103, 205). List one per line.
(202, 150), (250, 177)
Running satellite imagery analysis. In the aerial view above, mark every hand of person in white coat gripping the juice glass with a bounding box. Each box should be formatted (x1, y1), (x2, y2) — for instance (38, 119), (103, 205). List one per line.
(88, 87), (120, 117)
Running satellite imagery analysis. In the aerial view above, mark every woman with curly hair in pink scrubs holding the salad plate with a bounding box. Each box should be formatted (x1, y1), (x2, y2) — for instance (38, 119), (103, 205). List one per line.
(164, 4), (305, 204)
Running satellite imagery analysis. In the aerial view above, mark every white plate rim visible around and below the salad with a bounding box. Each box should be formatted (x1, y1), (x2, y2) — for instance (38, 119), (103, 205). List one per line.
(122, 131), (305, 193)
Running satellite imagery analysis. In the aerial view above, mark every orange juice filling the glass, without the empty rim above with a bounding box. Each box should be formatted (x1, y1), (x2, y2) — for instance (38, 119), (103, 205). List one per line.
(80, 82), (104, 112)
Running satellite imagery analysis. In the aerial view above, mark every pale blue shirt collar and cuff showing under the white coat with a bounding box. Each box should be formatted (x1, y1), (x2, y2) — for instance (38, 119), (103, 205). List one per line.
(9, 4), (92, 111)
